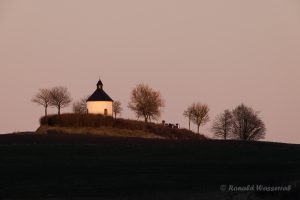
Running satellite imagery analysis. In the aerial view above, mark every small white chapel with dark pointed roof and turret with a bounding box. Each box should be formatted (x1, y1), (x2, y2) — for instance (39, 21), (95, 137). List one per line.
(86, 79), (113, 116)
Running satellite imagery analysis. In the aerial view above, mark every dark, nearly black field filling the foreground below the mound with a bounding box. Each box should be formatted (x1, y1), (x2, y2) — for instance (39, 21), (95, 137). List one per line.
(0, 133), (300, 199)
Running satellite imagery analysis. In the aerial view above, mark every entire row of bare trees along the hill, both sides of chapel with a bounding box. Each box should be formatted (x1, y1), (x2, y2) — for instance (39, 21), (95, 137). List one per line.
(32, 84), (266, 140)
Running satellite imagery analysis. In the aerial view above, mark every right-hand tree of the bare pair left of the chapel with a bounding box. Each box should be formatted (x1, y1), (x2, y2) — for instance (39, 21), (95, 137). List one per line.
(50, 87), (72, 115)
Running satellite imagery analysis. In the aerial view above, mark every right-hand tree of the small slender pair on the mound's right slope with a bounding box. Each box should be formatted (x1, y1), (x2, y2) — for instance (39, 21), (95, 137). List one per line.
(191, 103), (209, 133)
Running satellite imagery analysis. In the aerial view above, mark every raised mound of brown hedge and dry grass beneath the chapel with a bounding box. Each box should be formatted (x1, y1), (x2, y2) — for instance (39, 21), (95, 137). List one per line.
(36, 114), (207, 140)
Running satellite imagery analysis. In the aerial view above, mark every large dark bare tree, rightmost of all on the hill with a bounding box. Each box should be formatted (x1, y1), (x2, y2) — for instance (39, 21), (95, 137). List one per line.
(232, 104), (266, 140)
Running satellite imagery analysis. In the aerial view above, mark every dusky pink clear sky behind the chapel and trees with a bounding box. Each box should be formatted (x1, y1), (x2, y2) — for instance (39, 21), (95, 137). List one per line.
(0, 0), (300, 144)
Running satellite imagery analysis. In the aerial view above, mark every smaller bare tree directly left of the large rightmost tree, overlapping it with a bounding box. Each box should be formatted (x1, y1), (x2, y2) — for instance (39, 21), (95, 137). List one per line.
(211, 110), (232, 140)
